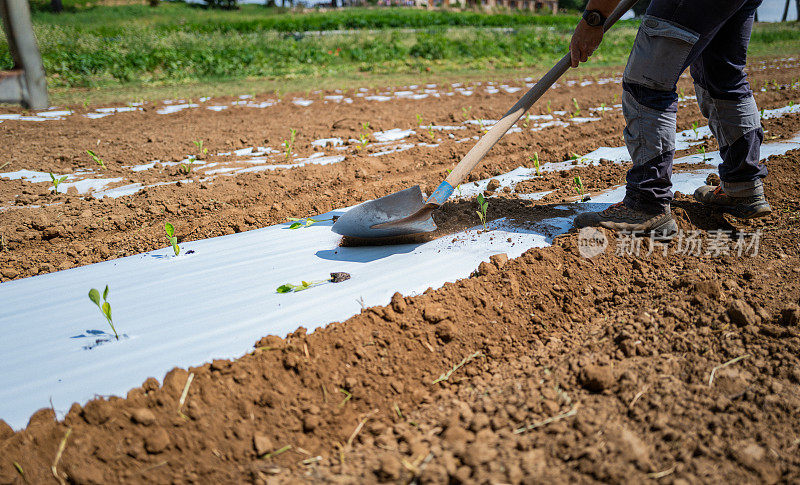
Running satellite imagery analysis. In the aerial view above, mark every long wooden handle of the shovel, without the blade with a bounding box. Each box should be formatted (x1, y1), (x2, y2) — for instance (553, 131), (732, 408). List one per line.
(437, 0), (638, 193)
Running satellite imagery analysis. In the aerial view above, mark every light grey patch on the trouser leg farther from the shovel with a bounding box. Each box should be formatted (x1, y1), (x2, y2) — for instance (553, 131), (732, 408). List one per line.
(694, 84), (761, 146)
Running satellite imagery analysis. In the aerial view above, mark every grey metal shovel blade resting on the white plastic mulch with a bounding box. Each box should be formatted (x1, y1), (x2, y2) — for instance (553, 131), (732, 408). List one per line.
(331, 185), (436, 239)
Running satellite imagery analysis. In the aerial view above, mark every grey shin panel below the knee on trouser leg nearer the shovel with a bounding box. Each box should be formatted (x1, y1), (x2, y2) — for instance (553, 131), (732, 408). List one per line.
(622, 91), (677, 165)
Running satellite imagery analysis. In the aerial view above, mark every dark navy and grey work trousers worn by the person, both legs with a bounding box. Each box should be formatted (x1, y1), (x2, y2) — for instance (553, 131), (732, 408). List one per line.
(622, 0), (767, 213)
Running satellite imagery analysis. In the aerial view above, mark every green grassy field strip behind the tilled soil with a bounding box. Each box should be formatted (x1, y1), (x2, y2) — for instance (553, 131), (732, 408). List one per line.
(0, 3), (800, 102)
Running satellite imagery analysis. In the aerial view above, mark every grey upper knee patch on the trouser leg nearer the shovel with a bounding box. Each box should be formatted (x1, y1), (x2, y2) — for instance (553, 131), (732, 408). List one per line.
(622, 15), (700, 91)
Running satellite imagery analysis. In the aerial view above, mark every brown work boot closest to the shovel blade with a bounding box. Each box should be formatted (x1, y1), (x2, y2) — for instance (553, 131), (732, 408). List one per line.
(573, 202), (678, 239)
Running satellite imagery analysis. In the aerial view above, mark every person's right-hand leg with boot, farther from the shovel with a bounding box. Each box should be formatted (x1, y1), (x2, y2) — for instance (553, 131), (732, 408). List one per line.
(691, 0), (771, 218)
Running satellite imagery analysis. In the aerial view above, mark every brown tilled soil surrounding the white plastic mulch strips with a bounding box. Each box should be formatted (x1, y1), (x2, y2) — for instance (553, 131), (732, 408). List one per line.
(0, 58), (800, 483)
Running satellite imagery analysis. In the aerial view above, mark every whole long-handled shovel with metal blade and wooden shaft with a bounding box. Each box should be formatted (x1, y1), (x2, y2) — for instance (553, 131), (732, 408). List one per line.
(331, 0), (638, 239)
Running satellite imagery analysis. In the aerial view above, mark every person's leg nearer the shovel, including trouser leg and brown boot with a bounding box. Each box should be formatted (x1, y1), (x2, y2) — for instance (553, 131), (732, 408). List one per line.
(575, 0), (747, 231)
